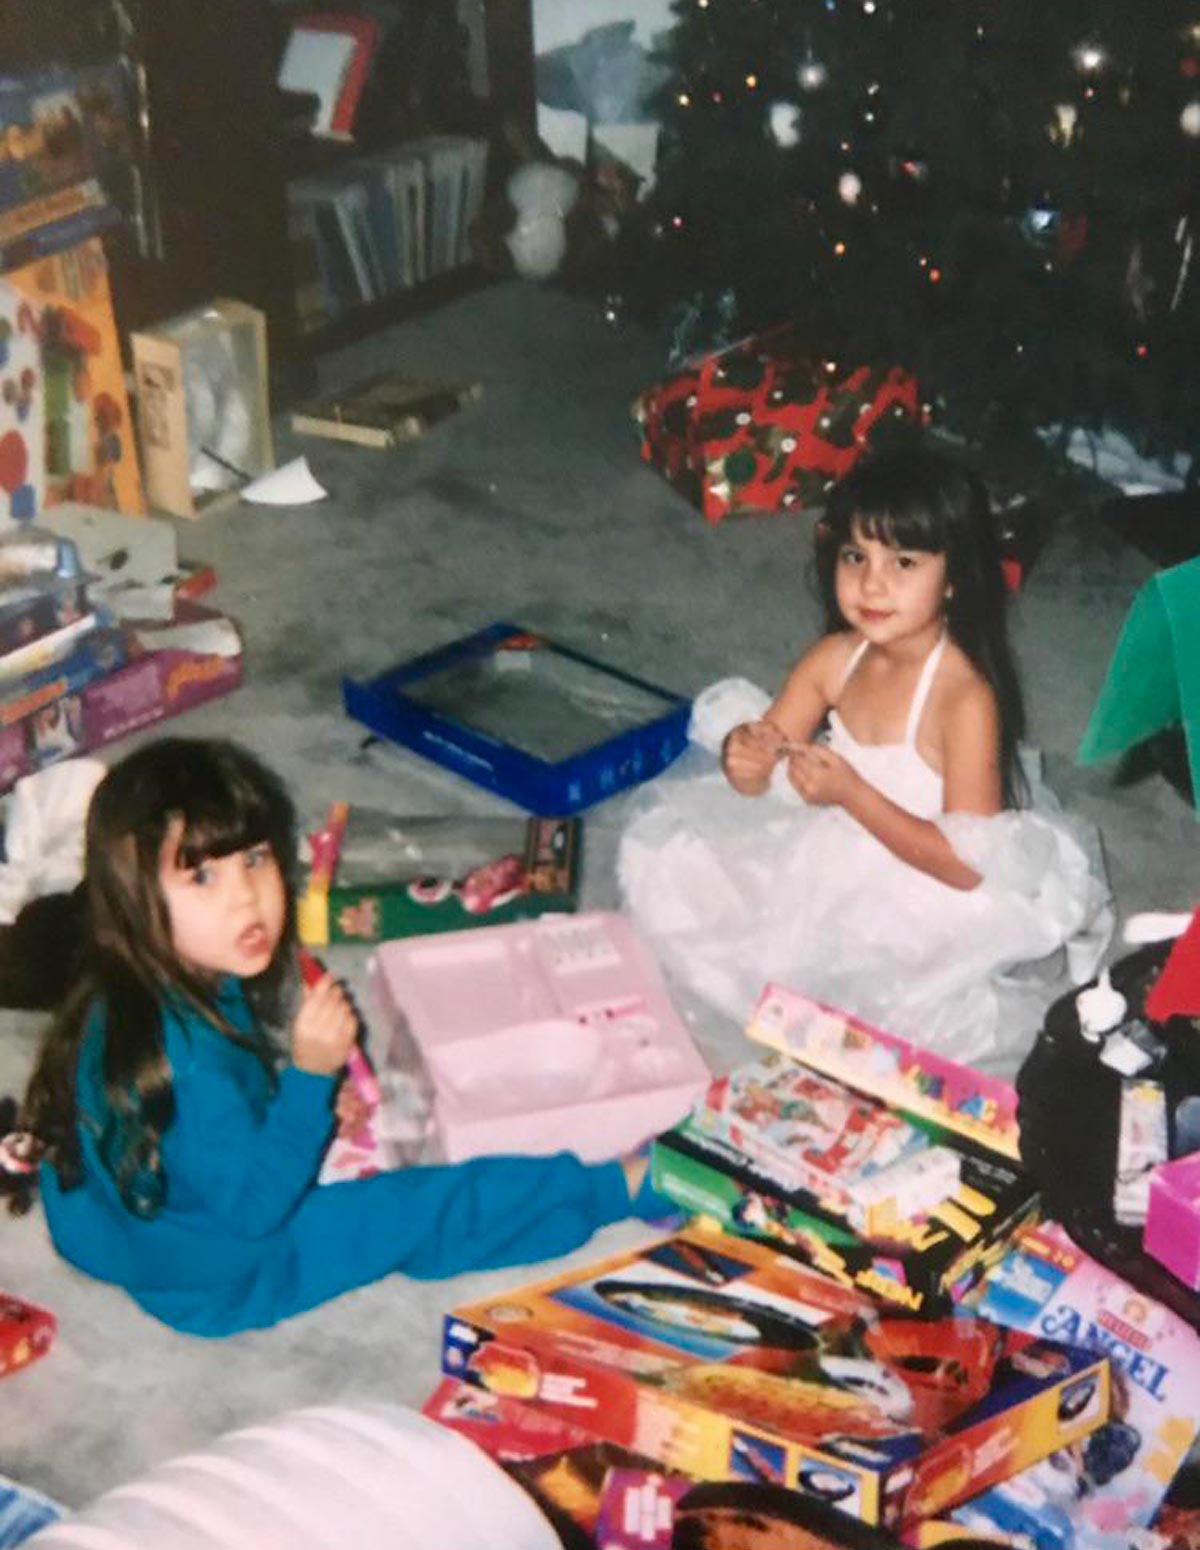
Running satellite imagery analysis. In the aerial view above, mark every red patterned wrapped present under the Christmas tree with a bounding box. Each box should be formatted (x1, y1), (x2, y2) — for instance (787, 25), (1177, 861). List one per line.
(633, 324), (919, 522)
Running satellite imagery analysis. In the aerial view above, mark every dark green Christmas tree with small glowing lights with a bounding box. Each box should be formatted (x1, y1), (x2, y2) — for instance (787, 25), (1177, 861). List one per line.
(653, 0), (1200, 456)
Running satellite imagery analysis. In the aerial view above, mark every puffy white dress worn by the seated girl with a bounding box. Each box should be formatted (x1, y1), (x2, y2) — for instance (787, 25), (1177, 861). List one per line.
(619, 637), (1113, 1073)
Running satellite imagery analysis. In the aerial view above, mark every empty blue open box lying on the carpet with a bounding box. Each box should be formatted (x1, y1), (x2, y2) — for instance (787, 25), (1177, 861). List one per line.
(343, 623), (691, 817)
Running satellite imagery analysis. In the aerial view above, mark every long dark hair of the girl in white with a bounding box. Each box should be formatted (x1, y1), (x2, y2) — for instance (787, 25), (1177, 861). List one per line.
(816, 446), (1025, 806)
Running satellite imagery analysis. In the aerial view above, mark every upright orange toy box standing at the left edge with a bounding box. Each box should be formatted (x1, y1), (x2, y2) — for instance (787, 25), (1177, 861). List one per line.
(0, 237), (143, 524)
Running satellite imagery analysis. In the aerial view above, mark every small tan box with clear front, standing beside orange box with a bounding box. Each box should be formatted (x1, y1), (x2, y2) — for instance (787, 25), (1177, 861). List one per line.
(130, 299), (274, 516)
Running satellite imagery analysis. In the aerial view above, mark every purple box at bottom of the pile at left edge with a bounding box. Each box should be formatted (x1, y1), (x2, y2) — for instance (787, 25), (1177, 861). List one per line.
(0, 603), (242, 791)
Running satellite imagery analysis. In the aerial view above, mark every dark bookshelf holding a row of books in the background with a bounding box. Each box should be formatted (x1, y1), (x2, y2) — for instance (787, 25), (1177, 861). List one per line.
(6, 0), (535, 392)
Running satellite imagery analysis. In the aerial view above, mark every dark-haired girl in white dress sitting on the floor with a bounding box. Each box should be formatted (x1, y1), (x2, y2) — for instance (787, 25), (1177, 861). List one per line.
(619, 450), (1112, 1070)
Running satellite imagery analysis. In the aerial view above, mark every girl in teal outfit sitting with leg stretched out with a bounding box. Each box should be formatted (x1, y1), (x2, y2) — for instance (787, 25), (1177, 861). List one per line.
(11, 738), (664, 1335)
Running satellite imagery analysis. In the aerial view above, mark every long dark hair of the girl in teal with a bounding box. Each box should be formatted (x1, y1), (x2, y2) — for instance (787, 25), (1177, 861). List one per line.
(14, 738), (296, 1215)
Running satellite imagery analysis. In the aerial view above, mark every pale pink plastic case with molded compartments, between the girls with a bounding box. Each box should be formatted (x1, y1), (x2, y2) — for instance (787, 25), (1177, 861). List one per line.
(371, 911), (709, 1161)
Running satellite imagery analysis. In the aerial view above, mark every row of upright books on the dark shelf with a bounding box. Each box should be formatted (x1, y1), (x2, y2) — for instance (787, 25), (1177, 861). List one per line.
(288, 135), (487, 332)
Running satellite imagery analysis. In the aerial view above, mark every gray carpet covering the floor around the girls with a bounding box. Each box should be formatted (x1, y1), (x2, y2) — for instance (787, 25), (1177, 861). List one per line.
(0, 284), (1195, 1505)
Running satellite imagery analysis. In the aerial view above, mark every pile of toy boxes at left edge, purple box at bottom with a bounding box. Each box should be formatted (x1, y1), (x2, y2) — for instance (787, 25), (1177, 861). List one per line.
(0, 507), (242, 791)
